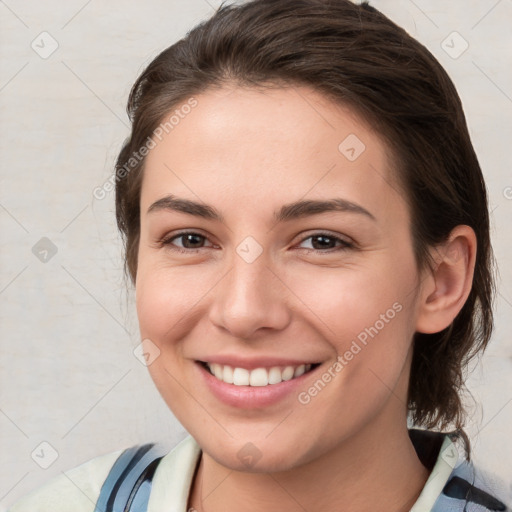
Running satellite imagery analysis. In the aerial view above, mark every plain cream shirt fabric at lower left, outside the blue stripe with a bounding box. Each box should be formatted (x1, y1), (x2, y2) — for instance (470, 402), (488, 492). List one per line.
(8, 450), (123, 512)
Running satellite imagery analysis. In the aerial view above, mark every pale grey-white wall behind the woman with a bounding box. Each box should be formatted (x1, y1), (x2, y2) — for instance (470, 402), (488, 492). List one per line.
(0, 0), (512, 510)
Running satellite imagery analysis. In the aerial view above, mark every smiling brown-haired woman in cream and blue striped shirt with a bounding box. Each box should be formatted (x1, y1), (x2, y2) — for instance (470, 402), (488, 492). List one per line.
(7, 0), (507, 512)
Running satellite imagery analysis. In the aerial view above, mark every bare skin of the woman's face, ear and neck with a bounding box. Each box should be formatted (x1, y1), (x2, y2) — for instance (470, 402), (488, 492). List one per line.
(136, 85), (476, 512)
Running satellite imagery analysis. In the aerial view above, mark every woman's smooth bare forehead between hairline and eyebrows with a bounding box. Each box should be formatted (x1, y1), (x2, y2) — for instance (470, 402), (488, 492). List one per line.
(141, 86), (408, 223)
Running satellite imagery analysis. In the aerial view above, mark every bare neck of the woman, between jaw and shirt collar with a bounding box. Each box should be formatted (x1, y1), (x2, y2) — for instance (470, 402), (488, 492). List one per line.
(189, 416), (429, 512)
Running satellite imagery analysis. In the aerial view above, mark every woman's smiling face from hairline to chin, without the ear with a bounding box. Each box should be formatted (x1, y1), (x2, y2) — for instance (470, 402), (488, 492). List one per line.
(136, 86), (428, 471)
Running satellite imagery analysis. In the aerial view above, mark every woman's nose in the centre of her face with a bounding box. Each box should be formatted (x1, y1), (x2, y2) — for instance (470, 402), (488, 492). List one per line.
(210, 249), (292, 340)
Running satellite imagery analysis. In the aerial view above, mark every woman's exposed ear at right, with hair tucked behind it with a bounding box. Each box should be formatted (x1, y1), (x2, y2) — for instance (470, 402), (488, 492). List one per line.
(416, 225), (477, 334)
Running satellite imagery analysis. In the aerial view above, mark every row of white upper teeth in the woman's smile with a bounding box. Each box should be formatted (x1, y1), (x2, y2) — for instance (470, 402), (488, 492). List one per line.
(207, 363), (311, 387)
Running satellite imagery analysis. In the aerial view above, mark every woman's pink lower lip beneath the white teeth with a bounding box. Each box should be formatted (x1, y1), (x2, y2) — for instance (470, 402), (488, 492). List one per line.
(196, 362), (320, 409)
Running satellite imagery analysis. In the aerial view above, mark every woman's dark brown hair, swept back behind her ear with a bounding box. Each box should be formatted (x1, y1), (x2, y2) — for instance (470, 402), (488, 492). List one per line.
(116, 0), (494, 456)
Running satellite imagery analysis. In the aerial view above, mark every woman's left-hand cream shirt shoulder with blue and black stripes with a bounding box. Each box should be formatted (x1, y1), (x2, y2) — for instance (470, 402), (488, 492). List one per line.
(8, 436), (200, 512)
